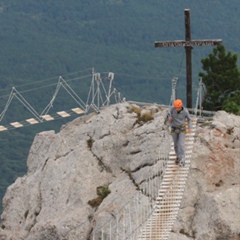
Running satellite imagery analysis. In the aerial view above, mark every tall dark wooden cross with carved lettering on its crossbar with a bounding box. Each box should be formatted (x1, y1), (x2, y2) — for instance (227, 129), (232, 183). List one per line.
(155, 9), (222, 108)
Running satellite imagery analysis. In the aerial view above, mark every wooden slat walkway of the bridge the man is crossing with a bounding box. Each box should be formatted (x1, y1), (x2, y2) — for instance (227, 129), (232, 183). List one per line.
(138, 118), (196, 240)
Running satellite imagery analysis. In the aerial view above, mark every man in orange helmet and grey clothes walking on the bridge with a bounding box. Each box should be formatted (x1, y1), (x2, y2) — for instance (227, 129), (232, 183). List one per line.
(168, 99), (192, 166)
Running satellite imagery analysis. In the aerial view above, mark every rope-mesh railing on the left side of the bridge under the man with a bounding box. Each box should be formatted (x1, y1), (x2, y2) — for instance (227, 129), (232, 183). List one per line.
(85, 126), (171, 240)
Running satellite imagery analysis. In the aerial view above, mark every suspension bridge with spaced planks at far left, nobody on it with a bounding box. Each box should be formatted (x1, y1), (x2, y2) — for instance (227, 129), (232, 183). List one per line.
(0, 69), (124, 131)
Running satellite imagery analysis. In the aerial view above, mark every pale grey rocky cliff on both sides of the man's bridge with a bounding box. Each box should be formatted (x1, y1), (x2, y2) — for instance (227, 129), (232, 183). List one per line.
(0, 102), (240, 240)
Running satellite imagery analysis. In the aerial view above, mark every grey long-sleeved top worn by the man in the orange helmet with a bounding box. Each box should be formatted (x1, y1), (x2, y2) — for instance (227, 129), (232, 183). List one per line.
(169, 107), (192, 128)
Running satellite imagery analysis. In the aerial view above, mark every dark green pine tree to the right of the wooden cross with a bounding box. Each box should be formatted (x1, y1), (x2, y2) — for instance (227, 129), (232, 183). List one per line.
(199, 45), (240, 114)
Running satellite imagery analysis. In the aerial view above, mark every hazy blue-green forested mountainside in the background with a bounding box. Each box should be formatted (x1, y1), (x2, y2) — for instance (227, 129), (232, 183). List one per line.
(0, 0), (240, 214)
